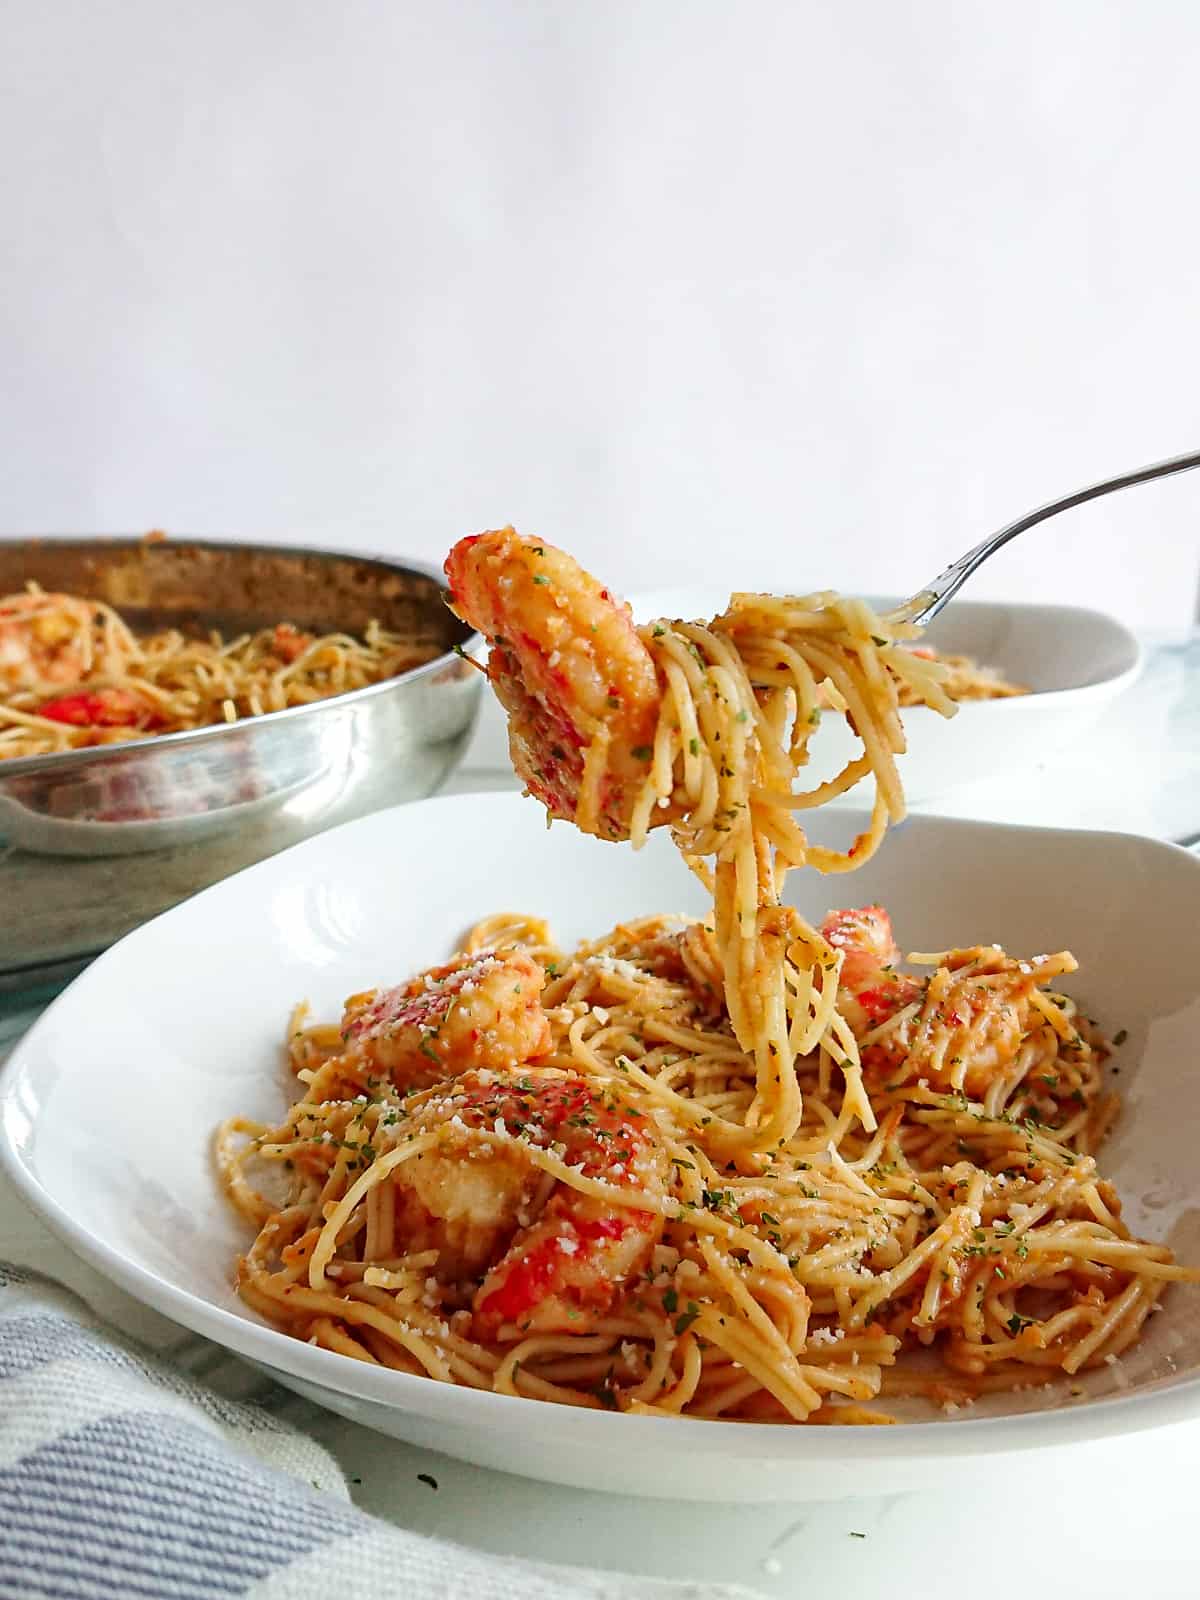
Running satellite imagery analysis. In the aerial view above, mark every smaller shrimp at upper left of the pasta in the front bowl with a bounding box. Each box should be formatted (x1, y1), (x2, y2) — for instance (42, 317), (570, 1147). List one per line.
(341, 950), (550, 1091)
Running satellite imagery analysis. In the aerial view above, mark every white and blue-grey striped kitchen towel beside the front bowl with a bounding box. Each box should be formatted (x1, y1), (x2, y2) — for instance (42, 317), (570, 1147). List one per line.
(0, 1264), (761, 1600)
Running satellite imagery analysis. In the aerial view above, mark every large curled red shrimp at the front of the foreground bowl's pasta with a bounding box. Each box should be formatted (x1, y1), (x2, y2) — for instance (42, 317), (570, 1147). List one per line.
(394, 1067), (667, 1339)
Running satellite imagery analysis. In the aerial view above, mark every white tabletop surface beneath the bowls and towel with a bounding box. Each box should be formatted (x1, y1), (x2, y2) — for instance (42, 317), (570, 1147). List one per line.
(0, 634), (1200, 1600)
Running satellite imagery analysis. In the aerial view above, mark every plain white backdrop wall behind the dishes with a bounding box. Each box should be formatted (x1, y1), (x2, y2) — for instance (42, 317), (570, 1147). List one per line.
(0, 0), (1200, 622)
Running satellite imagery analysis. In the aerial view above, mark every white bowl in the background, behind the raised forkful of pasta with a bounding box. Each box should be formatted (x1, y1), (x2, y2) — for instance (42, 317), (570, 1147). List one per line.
(467, 584), (1142, 805)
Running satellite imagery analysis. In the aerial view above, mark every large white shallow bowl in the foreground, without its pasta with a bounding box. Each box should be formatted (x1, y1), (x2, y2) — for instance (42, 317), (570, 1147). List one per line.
(0, 795), (1200, 1501)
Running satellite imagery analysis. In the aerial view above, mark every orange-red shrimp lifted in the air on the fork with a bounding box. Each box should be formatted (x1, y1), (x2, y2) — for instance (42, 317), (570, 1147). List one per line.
(445, 528), (664, 838)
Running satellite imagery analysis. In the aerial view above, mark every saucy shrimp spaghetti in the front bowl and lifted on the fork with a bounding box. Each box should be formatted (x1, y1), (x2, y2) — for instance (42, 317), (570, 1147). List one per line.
(219, 530), (1197, 1422)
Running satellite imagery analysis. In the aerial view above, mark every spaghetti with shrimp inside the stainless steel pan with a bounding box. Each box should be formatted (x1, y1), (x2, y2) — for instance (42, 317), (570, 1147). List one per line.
(0, 584), (443, 760)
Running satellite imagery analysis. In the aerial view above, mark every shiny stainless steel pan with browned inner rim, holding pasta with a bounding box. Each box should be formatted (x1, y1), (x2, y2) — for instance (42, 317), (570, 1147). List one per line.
(0, 538), (482, 989)
